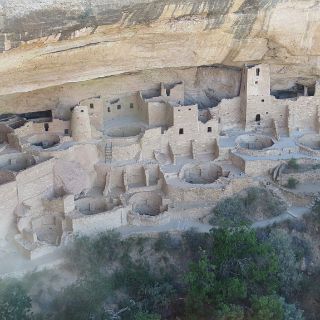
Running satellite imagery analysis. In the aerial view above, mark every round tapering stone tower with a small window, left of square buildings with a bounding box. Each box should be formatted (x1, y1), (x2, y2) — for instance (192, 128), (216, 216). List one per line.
(71, 106), (91, 142)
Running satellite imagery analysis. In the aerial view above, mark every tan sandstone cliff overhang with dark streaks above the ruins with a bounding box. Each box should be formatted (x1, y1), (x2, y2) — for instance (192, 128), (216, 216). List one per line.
(0, 0), (320, 107)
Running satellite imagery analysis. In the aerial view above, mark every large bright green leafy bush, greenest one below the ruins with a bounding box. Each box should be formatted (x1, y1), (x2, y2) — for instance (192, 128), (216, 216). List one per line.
(186, 228), (279, 319)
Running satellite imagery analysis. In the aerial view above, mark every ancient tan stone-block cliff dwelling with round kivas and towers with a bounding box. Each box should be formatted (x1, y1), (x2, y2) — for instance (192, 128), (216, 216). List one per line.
(0, 64), (320, 259)
